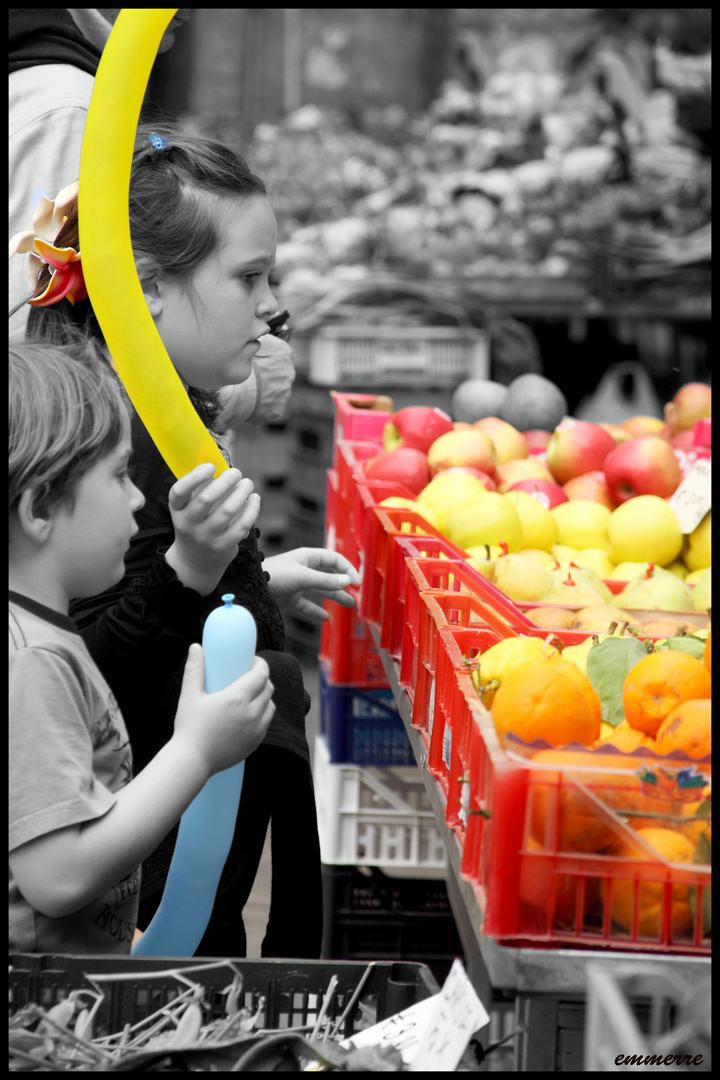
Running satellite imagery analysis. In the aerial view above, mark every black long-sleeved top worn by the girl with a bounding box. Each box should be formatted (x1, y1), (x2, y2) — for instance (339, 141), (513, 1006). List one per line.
(70, 411), (310, 772)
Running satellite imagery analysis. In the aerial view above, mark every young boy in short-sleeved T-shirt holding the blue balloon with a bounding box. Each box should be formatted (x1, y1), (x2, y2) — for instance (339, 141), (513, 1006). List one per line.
(10, 343), (274, 954)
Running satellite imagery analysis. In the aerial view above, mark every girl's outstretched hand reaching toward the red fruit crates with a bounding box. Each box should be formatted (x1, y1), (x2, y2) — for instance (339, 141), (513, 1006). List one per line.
(262, 548), (363, 622)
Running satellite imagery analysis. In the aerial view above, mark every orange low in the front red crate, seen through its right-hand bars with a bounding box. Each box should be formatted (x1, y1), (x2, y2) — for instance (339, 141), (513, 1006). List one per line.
(610, 828), (695, 939)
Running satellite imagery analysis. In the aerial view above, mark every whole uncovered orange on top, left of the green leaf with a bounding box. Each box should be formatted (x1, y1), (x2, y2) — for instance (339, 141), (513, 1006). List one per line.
(492, 658), (601, 746)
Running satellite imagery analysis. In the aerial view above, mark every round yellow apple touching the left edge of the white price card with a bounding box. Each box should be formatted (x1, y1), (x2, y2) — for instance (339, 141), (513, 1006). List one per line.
(604, 495), (683, 566)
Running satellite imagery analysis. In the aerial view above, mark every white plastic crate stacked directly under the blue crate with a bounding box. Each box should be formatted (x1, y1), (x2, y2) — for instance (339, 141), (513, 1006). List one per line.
(313, 735), (447, 876)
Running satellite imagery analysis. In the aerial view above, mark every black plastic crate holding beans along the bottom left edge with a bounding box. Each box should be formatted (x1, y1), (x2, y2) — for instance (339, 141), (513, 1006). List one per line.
(9, 954), (439, 1038)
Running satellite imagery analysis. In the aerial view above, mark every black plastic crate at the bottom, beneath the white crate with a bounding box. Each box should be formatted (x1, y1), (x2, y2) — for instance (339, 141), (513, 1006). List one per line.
(323, 864), (464, 984)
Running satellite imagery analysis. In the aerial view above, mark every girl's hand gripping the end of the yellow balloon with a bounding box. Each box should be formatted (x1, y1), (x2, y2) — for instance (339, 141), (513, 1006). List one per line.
(165, 464), (260, 596)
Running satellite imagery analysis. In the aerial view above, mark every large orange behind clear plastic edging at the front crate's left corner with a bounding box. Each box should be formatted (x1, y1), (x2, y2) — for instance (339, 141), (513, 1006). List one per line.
(529, 750), (658, 853)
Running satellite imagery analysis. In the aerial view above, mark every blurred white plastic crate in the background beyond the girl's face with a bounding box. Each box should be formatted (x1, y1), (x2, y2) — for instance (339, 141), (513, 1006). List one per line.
(293, 323), (490, 389)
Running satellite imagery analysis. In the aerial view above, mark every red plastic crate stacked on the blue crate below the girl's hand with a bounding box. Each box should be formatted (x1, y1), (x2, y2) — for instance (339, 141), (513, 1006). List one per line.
(320, 585), (390, 688)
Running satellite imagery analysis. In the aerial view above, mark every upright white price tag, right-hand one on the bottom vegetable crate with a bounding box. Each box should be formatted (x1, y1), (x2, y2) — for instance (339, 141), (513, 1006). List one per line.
(409, 960), (490, 1072)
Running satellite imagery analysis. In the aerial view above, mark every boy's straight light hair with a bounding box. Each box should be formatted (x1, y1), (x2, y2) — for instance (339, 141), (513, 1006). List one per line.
(9, 341), (130, 517)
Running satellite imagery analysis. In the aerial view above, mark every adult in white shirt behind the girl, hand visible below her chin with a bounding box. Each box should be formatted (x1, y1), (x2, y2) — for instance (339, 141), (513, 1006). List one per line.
(8, 8), (295, 431)
